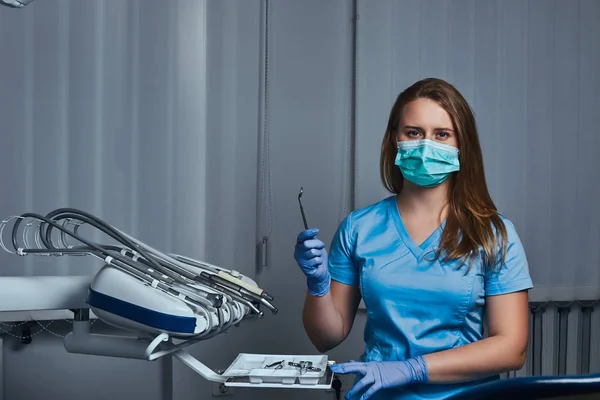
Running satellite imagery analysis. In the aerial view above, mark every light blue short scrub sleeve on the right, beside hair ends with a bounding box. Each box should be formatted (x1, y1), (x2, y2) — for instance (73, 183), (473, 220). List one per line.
(485, 218), (533, 296)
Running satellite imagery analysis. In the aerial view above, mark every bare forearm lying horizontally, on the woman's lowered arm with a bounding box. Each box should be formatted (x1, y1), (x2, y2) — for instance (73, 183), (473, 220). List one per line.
(424, 336), (526, 383)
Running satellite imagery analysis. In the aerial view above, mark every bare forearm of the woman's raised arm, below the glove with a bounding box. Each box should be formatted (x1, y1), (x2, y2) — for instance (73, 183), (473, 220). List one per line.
(302, 292), (345, 353)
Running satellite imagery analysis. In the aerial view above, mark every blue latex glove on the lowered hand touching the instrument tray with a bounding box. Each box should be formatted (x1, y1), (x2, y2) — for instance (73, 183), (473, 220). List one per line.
(331, 356), (428, 400)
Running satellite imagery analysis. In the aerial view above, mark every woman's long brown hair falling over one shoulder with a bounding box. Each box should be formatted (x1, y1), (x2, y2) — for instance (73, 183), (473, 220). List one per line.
(380, 78), (507, 271)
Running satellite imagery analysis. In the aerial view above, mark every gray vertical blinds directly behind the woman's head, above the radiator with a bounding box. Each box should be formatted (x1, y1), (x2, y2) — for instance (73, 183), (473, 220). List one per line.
(356, 0), (600, 300)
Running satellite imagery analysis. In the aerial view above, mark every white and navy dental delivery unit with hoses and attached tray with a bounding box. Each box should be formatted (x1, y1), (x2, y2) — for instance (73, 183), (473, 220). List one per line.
(0, 208), (333, 389)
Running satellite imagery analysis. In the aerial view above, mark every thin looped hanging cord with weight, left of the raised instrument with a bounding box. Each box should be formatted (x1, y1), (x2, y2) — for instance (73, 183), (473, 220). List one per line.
(259, 0), (273, 271)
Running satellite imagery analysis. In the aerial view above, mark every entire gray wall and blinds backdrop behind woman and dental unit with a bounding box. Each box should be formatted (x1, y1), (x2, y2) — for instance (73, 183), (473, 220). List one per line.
(0, 0), (600, 400)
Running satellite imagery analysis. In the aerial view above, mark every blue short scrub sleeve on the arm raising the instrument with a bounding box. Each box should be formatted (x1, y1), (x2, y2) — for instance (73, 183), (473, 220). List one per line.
(328, 214), (359, 286)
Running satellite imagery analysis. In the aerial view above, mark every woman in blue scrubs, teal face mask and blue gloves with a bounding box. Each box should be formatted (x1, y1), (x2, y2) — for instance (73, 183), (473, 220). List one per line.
(295, 79), (532, 400)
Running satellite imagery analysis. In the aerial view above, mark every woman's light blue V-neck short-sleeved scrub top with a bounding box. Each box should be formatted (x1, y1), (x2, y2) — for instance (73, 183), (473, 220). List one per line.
(329, 196), (533, 400)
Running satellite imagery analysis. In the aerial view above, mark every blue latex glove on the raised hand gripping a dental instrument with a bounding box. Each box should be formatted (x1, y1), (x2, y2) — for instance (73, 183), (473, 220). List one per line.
(294, 229), (331, 296)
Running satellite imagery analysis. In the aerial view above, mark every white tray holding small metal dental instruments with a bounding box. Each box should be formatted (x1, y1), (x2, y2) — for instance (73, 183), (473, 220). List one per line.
(222, 353), (332, 387)
